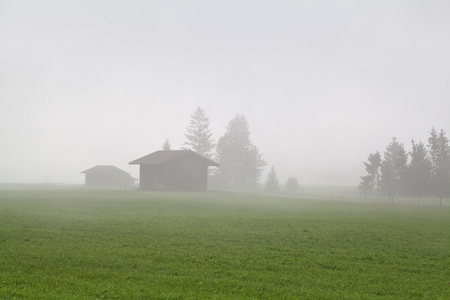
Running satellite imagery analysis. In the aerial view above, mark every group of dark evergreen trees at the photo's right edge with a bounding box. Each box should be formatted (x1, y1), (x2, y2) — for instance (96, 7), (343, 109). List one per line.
(359, 127), (450, 201)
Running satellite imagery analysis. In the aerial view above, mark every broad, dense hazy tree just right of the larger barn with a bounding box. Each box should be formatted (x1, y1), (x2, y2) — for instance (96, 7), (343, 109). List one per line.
(216, 115), (266, 190)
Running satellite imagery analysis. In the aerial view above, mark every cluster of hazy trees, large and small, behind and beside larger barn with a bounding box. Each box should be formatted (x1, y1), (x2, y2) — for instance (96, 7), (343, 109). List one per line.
(162, 107), (298, 193)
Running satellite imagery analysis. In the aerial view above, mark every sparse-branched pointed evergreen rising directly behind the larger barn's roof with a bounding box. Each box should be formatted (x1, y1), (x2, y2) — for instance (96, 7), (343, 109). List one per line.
(183, 107), (215, 158)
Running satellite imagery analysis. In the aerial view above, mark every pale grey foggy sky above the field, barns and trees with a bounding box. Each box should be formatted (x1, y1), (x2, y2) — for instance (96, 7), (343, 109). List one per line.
(0, 0), (450, 185)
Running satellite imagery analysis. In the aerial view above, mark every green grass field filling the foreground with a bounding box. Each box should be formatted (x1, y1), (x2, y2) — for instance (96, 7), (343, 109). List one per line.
(0, 189), (450, 299)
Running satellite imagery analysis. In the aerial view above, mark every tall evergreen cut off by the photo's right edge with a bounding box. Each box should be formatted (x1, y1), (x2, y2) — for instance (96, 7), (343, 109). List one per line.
(428, 128), (450, 199)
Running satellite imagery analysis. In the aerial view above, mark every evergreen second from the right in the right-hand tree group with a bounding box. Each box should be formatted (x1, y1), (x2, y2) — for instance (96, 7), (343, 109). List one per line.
(407, 140), (431, 199)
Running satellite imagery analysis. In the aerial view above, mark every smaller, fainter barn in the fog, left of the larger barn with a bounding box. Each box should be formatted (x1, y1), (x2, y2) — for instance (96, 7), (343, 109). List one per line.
(81, 166), (137, 189)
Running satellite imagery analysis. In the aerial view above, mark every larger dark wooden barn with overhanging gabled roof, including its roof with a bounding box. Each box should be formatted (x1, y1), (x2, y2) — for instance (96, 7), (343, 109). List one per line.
(130, 150), (219, 191)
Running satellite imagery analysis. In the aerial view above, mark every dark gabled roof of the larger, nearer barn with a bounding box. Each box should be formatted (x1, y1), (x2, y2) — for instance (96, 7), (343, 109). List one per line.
(130, 150), (219, 167)
